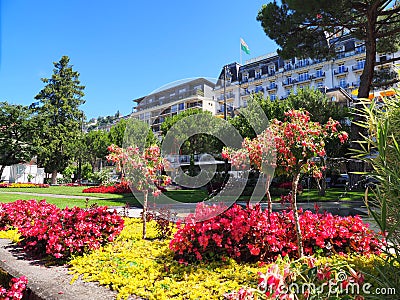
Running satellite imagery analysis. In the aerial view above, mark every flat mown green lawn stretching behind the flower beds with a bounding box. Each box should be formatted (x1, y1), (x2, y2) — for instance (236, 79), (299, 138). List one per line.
(0, 186), (364, 208)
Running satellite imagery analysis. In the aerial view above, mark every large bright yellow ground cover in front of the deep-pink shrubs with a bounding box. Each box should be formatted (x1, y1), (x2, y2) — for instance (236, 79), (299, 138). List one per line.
(70, 219), (379, 300)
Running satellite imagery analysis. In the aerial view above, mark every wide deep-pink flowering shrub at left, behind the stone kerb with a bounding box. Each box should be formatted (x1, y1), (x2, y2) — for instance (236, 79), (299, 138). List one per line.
(0, 200), (123, 258)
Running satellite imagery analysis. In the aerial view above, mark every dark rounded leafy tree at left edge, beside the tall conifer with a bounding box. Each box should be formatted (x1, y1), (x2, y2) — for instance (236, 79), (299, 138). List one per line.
(0, 102), (35, 178)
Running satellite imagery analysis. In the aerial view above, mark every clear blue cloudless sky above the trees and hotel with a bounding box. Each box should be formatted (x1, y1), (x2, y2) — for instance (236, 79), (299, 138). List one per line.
(0, 0), (277, 119)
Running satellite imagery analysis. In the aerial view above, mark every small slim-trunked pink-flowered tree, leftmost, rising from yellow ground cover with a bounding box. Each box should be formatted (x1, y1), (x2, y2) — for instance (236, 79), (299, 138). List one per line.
(107, 145), (170, 239)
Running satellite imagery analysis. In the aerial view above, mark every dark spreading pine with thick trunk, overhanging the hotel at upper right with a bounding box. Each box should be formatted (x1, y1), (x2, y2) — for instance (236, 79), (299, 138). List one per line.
(257, 0), (400, 98)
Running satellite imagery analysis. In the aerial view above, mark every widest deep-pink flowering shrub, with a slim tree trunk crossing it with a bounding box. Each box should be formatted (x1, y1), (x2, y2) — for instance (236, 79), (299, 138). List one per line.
(170, 205), (381, 262)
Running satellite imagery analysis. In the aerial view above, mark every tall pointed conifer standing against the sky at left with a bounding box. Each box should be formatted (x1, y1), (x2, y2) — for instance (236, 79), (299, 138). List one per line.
(35, 56), (85, 184)
